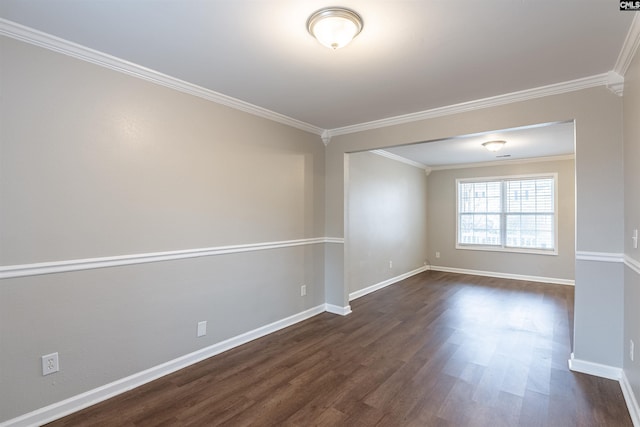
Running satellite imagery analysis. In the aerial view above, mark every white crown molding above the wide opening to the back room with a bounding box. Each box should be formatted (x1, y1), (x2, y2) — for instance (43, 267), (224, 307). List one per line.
(327, 73), (609, 138)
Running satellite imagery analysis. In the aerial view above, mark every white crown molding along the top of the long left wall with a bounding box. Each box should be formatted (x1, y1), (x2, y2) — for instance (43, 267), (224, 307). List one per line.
(0, 18), (324, 135)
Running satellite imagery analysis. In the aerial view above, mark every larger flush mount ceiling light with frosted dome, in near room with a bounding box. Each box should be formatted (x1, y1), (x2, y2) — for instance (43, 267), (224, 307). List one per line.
(307, 7), (364, 49)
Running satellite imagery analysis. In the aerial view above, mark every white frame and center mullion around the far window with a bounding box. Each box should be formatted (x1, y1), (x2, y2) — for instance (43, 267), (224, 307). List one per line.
(455, 172), (560, 256)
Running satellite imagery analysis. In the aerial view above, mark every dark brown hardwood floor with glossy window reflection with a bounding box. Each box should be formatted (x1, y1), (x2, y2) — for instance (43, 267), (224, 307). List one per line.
(50, 271), (632, 427)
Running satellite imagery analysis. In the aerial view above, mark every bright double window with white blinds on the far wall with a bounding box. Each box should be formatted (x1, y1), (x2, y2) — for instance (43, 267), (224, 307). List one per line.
(456, 174), (558, 255)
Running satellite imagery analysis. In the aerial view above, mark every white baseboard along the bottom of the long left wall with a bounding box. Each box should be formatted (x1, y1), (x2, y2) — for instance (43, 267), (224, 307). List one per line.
(0, 304), (325, 427)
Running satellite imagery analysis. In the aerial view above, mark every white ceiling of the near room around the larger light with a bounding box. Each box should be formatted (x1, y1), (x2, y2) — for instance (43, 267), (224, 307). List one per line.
(0, 0), (634, 164)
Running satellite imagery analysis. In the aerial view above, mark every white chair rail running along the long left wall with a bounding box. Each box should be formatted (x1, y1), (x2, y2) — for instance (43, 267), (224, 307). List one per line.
(0, 237), (344, 279)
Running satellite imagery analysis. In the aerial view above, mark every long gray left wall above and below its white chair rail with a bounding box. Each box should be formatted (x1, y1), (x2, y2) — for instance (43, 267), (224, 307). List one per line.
(0, 37), (328, 421)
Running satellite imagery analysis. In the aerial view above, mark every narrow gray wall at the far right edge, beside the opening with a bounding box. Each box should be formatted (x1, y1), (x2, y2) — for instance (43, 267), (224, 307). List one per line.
(622, 40), (640, 412)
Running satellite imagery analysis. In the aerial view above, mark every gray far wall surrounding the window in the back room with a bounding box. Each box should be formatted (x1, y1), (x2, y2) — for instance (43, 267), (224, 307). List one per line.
(427, 160), (575, 281)
